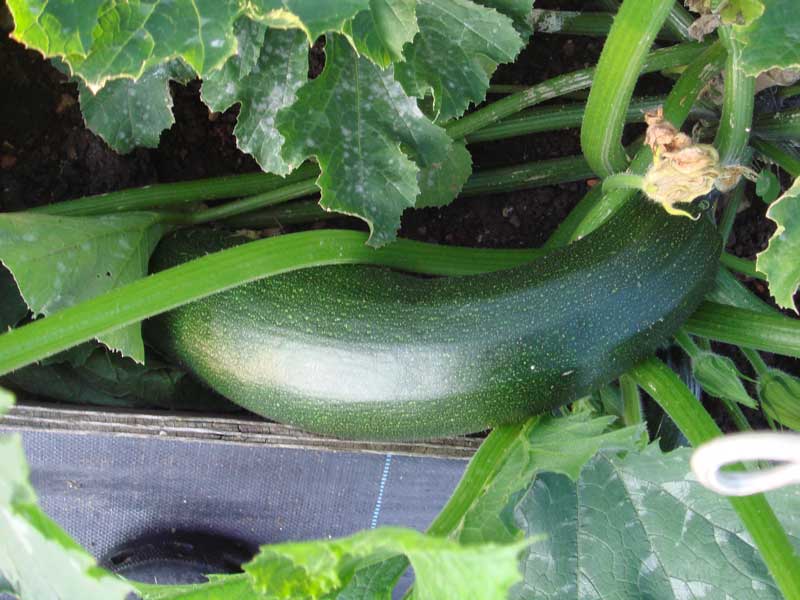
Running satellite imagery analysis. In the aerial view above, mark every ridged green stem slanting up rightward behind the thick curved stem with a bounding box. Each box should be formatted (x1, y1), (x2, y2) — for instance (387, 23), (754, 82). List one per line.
(447, 43), (708, 139)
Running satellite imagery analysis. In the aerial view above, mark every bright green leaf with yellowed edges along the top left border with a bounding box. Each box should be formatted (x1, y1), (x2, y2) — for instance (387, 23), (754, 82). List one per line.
(8, 0), (396, 92)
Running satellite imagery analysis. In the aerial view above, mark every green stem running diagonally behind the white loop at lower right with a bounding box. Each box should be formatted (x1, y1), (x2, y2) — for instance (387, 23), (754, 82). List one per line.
(631, 358), (800, 600)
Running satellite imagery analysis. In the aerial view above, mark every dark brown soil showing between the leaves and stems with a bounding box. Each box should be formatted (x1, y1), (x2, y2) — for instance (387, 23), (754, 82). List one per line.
(0, 0), (800, 426)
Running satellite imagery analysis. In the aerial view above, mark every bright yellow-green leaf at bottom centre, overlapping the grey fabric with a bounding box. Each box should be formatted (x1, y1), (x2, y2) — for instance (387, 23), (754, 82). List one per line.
(244, 528), (527, 600)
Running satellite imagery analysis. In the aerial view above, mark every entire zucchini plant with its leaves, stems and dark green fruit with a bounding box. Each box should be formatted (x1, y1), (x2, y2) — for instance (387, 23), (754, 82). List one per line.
(0, 0), (800, 600)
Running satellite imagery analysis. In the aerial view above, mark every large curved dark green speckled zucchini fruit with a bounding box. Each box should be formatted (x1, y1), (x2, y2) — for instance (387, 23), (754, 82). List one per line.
(146, 201), (720, 439)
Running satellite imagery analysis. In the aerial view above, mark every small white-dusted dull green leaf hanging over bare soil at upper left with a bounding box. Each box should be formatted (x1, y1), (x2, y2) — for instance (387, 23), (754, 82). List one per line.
(78, 60), (194, 154)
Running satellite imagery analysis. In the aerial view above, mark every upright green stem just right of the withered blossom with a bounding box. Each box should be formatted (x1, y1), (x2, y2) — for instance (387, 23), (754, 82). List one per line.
(714, 27), (755, 165)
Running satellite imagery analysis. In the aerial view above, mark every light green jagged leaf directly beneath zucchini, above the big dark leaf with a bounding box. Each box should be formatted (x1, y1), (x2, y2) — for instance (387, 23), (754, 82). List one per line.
(454, 414), (641, 544)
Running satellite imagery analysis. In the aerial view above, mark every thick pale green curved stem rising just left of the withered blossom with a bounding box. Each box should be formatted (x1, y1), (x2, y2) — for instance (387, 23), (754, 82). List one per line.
(581, 0), (674, 177)
